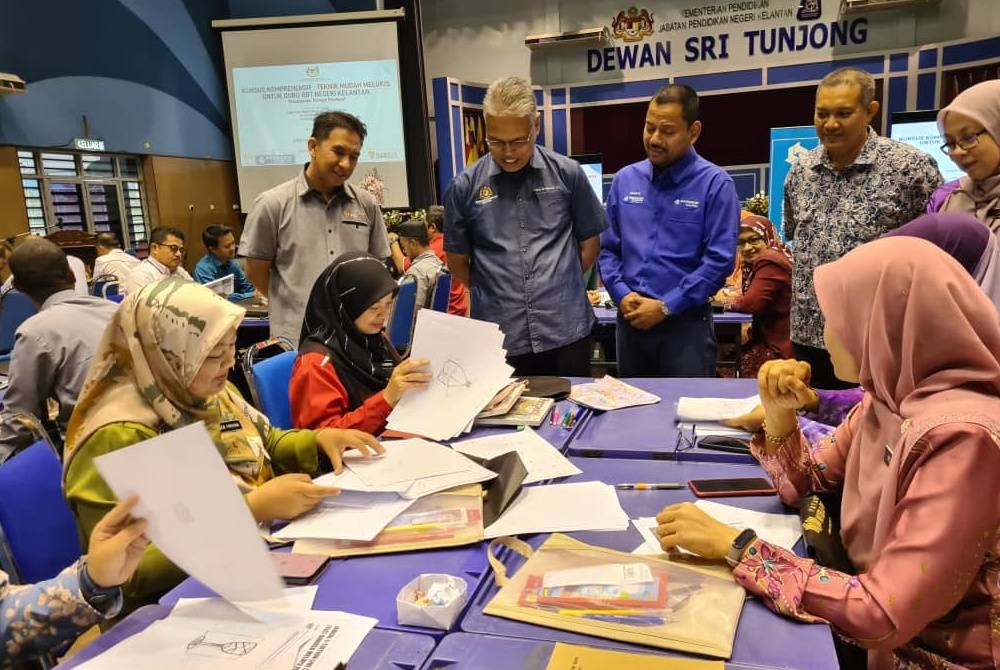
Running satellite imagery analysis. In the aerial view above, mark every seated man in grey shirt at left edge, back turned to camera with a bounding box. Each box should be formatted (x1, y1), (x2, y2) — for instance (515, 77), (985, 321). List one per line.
(0, 237), (118, 460)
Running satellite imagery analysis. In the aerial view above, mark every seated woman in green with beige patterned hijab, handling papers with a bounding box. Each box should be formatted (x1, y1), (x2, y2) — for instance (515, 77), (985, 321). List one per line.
(63, 278), (383, 611)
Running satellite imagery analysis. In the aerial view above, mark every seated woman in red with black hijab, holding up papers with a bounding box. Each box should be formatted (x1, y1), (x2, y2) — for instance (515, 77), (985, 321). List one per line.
(289, 252), (431, 433)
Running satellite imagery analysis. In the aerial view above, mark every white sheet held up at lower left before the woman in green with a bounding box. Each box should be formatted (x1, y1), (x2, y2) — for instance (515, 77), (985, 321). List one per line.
(94, 423), (282, 601)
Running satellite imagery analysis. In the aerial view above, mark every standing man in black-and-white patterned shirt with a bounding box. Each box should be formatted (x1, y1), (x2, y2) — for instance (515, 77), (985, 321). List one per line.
(783, 68), (941, 389)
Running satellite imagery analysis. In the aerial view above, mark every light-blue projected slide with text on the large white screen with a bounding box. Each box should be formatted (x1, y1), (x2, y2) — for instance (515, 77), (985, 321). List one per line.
(233, 60), (405, 167)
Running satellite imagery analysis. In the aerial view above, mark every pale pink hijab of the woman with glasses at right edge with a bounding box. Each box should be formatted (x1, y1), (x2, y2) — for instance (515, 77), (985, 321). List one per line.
(938, 80), (1000, 227)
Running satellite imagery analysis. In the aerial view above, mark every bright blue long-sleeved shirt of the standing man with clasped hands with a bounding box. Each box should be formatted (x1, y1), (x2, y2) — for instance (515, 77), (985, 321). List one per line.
(598, 148), (740, 314)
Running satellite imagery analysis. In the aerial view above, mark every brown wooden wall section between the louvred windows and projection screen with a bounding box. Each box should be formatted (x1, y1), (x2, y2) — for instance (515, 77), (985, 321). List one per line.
(144, 156), (242, 270)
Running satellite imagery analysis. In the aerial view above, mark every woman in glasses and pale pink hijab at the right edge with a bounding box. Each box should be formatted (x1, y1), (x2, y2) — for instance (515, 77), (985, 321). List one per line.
(927, 80), (1000, 234)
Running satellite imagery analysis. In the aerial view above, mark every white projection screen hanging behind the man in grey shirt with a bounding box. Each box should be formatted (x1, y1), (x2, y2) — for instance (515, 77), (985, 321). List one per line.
(222, 17), (410, 212)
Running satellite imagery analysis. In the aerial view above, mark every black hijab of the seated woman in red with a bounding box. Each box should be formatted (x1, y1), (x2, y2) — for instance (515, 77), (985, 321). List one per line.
(299, 251), (397, 410)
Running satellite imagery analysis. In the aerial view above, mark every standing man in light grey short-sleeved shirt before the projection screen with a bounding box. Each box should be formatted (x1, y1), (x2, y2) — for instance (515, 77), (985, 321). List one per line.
(240, 112), (389, 342)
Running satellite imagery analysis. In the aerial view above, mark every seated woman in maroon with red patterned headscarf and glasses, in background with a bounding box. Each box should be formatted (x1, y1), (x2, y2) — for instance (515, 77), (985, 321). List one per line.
(723, 215), (794, 378)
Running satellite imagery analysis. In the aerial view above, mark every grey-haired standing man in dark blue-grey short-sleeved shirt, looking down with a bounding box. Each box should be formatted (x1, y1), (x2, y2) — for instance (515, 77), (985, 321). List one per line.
(444, 77), (607, 376)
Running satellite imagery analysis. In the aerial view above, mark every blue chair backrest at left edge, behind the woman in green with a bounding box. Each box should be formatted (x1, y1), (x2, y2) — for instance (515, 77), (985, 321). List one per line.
(0, 440), (81, 584)
